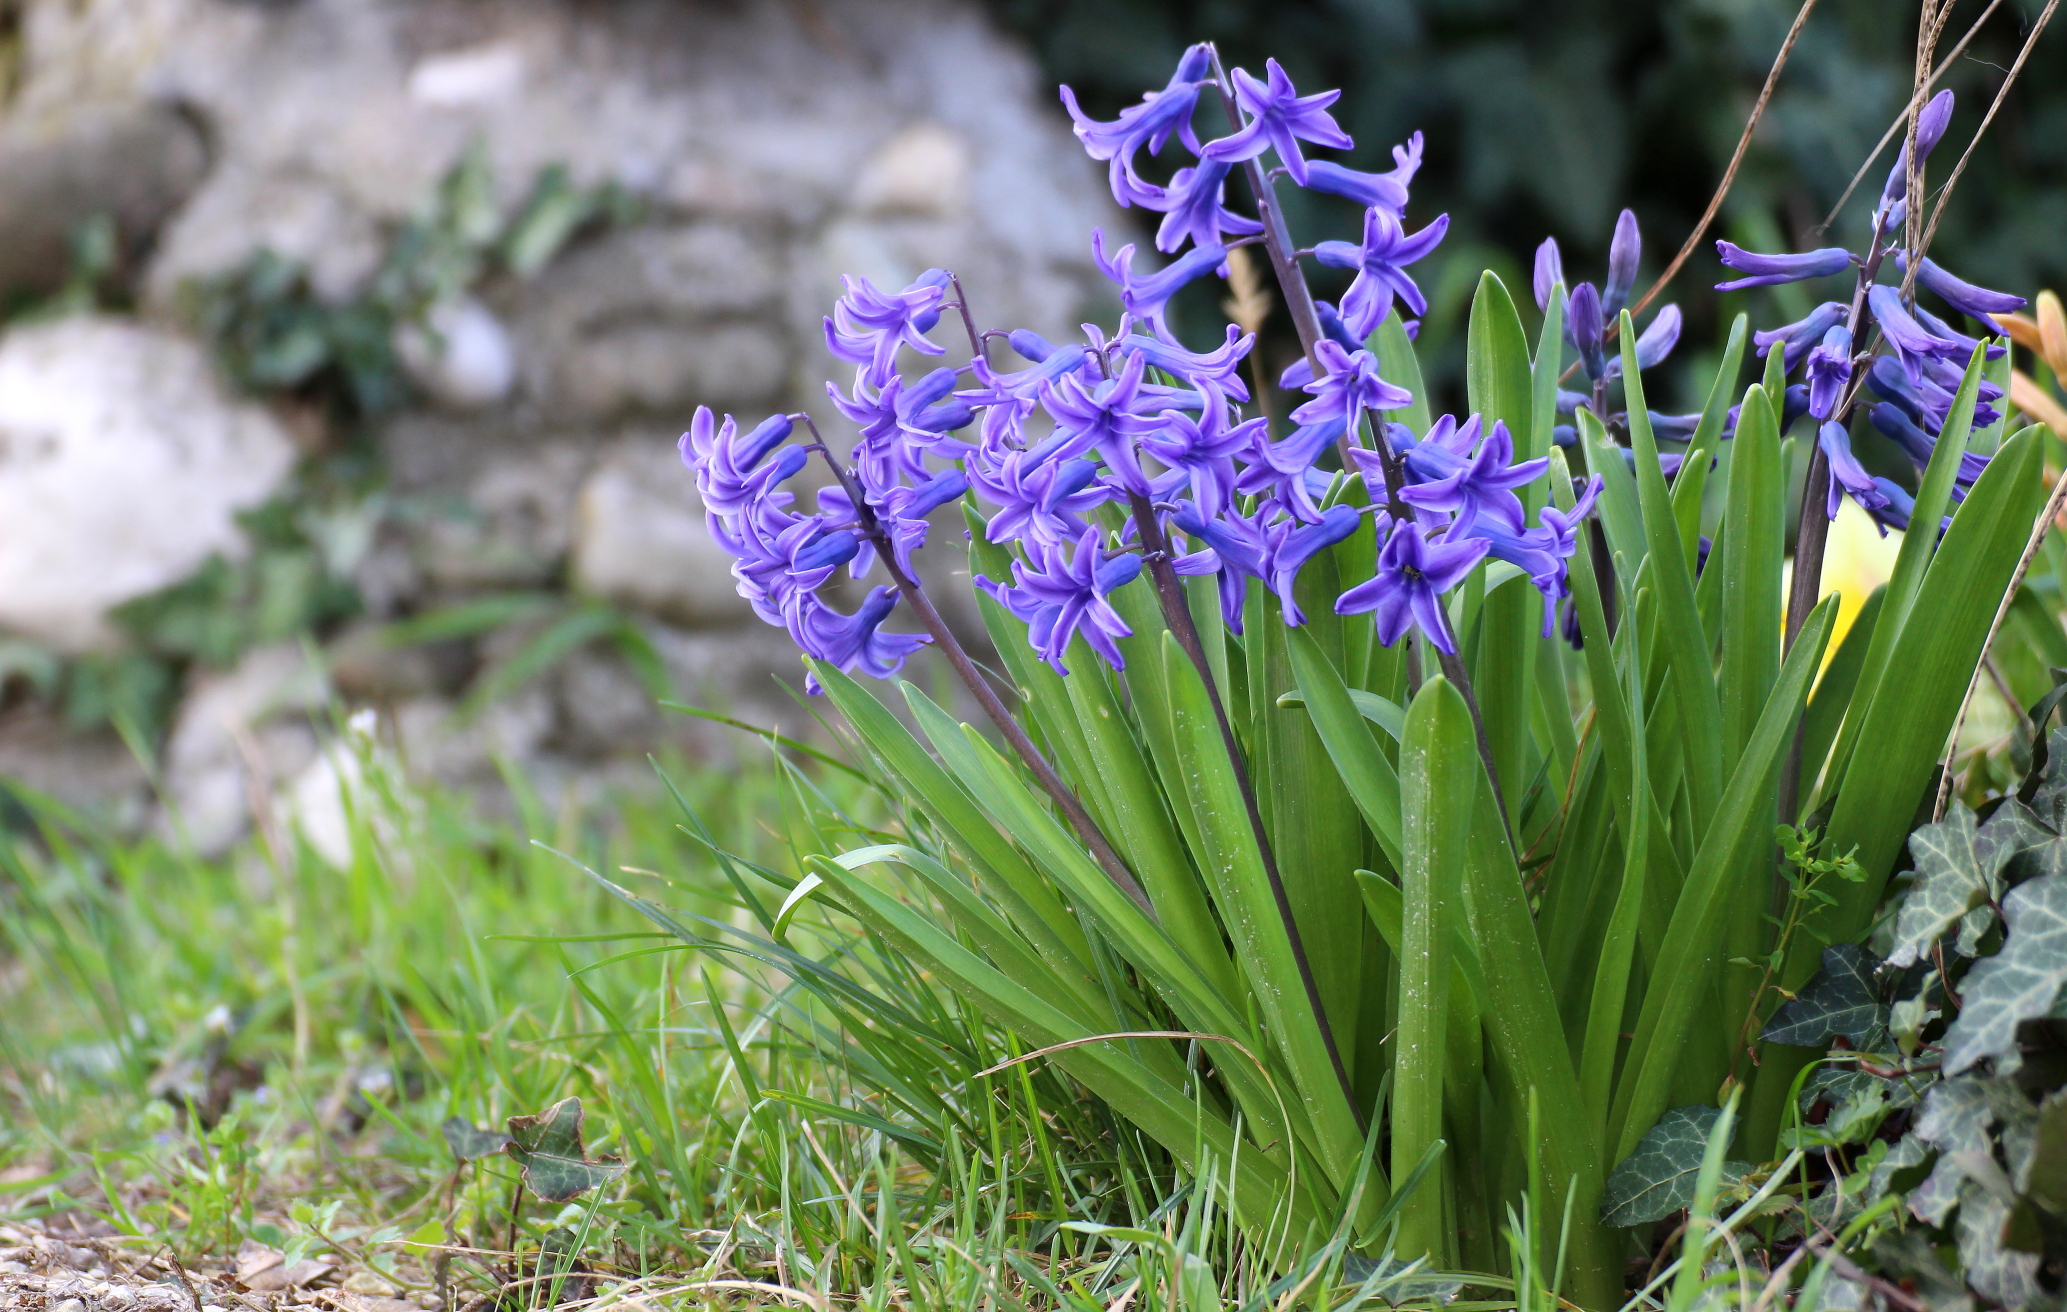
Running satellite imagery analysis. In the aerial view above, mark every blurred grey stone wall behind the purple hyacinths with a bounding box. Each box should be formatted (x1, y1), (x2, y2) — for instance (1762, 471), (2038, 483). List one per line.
(0, 0), (1112, 847)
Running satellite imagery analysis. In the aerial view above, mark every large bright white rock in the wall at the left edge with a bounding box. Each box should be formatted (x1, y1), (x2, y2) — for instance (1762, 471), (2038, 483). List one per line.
(0, 318), (294, 651)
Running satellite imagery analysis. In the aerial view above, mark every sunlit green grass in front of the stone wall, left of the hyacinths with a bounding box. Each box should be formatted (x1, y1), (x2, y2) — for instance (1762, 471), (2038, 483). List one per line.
(0, 729), (1471, 1308)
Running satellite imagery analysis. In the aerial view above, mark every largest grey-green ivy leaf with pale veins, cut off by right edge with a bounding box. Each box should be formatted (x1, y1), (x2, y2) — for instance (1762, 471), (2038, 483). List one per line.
(1945, 876), (2067, 1074)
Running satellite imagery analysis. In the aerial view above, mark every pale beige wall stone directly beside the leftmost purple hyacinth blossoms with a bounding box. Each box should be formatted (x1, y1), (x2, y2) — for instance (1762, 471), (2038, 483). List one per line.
(575, 442), (752, 624)
